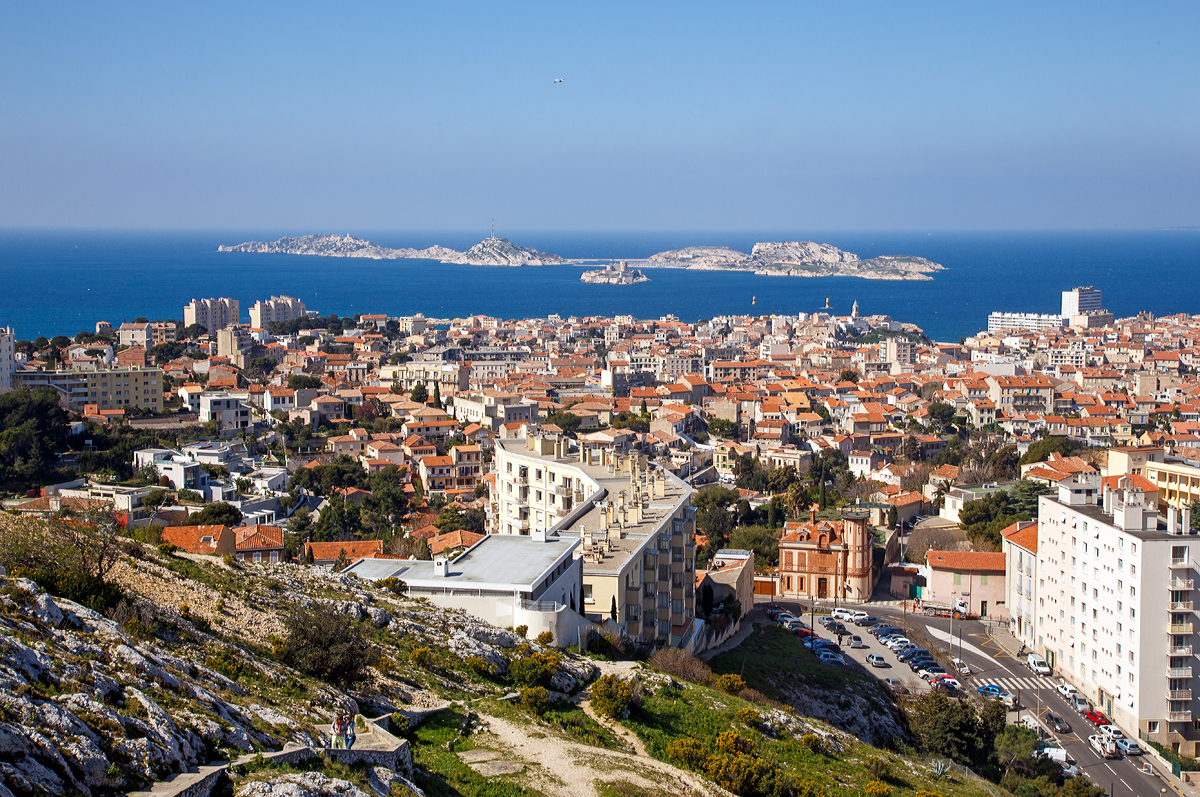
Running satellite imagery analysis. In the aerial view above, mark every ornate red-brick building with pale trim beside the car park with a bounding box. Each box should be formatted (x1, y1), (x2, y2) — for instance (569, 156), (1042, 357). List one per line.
(778, 504), (875, 601)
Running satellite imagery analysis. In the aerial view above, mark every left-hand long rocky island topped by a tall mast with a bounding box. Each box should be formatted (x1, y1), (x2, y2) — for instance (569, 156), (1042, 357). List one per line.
(217, 235), (566, 265)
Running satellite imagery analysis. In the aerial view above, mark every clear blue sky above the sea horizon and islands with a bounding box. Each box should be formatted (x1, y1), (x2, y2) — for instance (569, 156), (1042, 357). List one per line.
(0, 2), (1200, 232)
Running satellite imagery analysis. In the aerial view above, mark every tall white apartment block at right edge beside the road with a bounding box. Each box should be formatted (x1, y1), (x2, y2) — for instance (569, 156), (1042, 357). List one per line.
(1037, 475), (1200, 756)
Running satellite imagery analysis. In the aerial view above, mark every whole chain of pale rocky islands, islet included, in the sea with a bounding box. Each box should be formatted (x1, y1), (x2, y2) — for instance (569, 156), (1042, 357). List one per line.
(217, 234), (946, 279)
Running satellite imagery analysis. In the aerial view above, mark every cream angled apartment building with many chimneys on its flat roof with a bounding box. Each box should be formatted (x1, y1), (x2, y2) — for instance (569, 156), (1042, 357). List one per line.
(488, 435), (696, 647)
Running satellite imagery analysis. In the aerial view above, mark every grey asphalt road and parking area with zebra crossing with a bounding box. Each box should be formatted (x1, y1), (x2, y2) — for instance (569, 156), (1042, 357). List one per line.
(763, 603), (1189, 797)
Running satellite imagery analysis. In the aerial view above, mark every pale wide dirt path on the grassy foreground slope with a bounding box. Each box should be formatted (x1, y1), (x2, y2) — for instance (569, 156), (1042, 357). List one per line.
(475, 713), (728, 797)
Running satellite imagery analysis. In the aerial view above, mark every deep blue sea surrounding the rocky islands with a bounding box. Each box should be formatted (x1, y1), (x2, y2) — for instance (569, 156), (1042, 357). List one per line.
(0, 229), (1200, 341)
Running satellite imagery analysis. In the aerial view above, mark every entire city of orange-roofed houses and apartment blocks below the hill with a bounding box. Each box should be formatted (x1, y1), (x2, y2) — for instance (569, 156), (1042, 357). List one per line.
(0, 279), (1200, 793)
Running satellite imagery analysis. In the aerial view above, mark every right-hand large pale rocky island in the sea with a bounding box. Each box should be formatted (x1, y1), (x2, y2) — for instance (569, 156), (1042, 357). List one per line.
(646, 241), (946, 280)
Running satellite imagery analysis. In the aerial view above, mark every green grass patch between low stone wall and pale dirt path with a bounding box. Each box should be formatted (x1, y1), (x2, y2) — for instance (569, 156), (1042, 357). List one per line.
(410, 709), (541, 797)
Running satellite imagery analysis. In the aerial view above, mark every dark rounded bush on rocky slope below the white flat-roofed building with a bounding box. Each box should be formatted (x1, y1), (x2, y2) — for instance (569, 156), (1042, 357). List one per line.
(278, 607), (379, 688)
